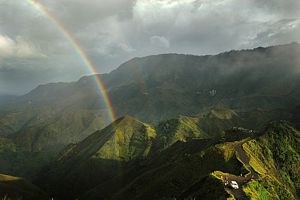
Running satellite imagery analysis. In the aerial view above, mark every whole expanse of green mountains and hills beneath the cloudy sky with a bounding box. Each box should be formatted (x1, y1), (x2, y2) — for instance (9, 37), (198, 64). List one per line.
(0, 43), (300, 199)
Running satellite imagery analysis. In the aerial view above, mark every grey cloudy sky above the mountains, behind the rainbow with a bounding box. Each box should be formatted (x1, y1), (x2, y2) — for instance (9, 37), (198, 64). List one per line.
(0, 0), (300, 94)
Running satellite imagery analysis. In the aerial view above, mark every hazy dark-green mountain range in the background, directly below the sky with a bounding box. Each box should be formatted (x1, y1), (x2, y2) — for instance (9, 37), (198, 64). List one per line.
(0, 43), (300, 151)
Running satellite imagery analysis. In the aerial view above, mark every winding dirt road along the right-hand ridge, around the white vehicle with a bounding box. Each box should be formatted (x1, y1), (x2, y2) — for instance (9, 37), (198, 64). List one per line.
(225, 140), (258, 200)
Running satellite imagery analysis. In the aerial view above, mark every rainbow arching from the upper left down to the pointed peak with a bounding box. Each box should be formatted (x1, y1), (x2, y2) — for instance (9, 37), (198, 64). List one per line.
(27, 0), (116, 121)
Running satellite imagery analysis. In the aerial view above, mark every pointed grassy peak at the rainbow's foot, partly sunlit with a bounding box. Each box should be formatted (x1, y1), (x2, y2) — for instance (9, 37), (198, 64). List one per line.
(37, 116), (156, 198)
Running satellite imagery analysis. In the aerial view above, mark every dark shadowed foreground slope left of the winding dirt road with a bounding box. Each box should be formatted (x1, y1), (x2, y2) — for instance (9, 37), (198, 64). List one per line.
(83, 139), (242, 199)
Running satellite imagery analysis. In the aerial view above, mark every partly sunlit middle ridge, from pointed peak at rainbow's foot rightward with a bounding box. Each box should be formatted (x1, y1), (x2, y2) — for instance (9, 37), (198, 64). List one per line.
(37, 109), (262, 198)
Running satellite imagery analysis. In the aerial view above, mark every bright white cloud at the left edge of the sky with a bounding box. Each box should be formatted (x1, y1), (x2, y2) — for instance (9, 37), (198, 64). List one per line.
(0, 35), (45, 58)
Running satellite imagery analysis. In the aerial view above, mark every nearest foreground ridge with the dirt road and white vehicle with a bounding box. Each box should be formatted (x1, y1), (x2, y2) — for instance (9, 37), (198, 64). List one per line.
(82, 122), (300, 199)
